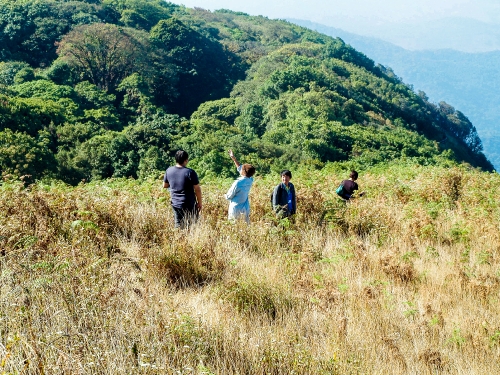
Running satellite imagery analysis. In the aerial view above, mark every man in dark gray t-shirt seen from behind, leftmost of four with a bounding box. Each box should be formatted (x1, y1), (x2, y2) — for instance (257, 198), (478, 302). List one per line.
(163, 150), (202, 228)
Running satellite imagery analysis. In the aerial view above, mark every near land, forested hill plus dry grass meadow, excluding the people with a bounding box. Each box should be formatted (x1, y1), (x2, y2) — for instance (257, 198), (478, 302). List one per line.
(0, 0), (500, 375)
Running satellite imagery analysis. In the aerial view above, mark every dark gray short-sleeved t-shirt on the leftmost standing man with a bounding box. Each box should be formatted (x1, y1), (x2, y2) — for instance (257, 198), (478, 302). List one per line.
(163, 166), (200, 210)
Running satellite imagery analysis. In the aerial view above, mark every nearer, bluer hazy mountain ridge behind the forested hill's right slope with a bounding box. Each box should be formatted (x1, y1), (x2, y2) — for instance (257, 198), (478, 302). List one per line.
(289, 19), (500, 170)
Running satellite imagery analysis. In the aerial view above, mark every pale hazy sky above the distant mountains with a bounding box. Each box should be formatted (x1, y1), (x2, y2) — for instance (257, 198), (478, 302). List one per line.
(173, 0), (500, 35)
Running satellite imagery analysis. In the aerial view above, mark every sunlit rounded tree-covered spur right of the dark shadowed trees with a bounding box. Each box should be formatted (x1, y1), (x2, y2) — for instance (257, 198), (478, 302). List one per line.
(227, 43), (489, 168)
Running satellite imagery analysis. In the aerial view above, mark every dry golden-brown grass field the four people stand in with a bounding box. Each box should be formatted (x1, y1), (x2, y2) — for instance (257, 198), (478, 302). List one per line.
(0, 166), (500, 374)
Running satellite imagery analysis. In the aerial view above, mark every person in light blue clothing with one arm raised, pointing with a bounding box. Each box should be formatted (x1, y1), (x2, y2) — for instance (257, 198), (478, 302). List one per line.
(225, 150), (255, 223)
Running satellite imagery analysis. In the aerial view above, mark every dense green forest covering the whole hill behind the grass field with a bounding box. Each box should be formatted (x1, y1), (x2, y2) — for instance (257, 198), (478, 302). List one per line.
(0, 0), (492, 184)
